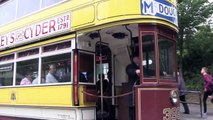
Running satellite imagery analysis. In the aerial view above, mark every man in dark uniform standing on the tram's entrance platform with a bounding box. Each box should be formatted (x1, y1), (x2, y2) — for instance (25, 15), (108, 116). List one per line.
(126, 55), (140, 120)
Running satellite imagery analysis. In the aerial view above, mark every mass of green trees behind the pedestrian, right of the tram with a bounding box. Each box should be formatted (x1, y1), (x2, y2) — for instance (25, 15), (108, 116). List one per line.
(177, 0), (213, 90)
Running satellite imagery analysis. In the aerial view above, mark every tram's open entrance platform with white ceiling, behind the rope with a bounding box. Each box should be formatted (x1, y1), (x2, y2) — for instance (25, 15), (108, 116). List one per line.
(77, 24), (138, 120)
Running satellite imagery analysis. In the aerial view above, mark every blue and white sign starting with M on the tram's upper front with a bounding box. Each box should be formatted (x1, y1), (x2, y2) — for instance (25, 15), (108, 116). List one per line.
(141, 0), (178, 26)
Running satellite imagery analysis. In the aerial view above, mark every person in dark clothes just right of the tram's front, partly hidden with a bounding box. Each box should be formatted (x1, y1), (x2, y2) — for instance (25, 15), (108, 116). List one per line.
(177, 69), (190, 114)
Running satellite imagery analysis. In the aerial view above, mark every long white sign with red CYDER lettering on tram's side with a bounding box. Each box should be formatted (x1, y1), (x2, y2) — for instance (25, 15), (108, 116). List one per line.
(0, 13), (71, 49)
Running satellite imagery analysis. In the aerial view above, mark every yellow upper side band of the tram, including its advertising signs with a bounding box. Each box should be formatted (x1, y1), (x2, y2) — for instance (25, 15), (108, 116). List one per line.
(0, 0), (178, 49)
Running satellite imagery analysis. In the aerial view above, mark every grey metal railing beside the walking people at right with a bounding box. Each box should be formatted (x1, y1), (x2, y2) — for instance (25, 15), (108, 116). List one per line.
(180, 90), (203, 118)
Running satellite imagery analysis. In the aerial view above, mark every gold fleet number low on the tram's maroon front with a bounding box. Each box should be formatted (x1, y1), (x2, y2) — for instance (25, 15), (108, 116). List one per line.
(163, 107), (180, 120)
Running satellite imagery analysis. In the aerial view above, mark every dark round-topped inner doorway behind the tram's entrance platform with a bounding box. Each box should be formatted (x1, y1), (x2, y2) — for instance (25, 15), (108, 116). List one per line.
(95, 42), (114, 120)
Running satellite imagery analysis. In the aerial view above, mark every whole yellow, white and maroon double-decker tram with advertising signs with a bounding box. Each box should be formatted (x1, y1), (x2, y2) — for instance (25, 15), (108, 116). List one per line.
(0, 0), (180, 120)
